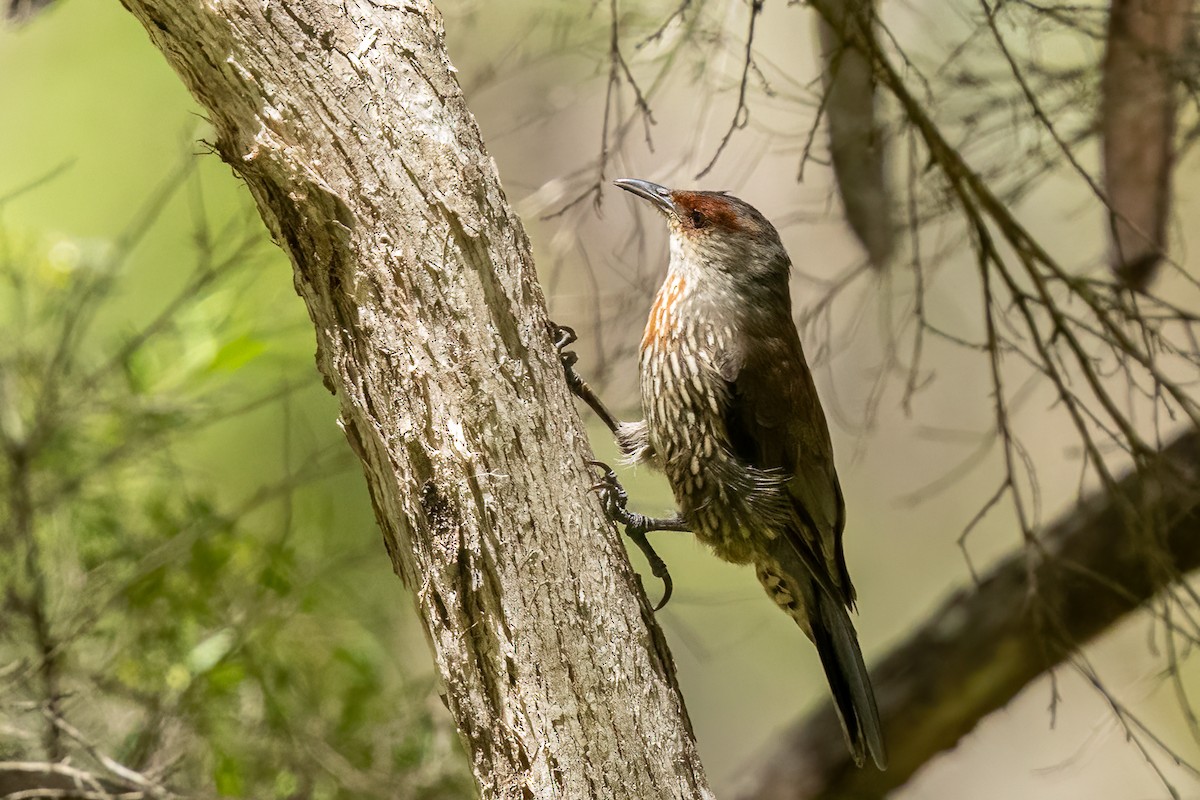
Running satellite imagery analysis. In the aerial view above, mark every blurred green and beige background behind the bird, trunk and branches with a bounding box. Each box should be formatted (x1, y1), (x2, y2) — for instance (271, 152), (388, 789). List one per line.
(0, 0), (1200, 800)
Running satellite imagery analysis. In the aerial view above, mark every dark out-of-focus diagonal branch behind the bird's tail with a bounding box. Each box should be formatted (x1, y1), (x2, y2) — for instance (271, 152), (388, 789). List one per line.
(739, 431), (1200, 800)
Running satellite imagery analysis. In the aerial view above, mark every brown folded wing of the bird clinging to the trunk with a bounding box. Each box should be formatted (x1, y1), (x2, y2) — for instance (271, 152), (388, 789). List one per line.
(720, 326), (854, 604)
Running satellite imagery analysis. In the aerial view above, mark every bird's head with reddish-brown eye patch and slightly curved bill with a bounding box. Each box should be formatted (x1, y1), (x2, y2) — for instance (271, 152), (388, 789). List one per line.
(613, 178), (791, 284)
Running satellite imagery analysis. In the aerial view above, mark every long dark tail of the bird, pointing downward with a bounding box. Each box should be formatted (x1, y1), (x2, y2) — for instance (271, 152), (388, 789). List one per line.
(805, 582), (888, 770)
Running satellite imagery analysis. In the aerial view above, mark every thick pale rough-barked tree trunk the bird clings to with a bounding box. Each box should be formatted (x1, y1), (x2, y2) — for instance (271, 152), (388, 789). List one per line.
(117, 0), (709, 798)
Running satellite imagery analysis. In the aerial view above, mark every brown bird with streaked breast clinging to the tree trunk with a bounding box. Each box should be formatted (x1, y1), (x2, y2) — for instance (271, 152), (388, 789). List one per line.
(595, 179), (887, 770)
